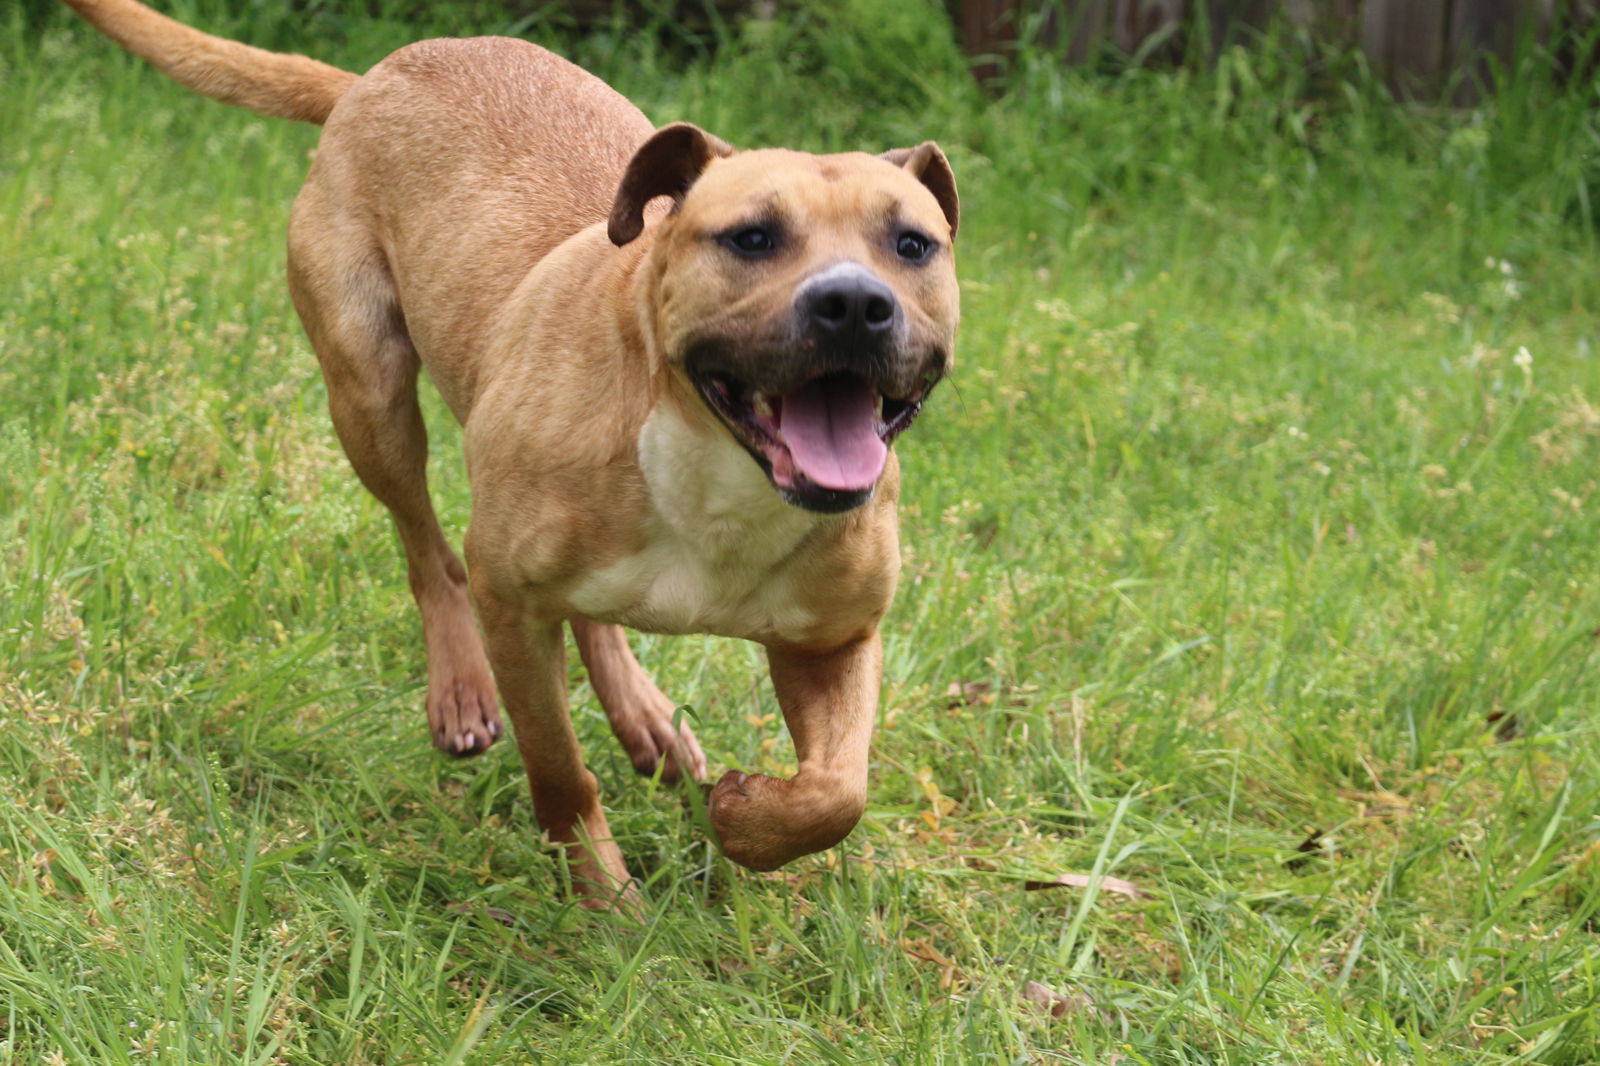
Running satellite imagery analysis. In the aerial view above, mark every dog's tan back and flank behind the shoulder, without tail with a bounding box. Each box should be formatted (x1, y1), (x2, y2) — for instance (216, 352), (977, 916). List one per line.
(291, 37), (653, 406)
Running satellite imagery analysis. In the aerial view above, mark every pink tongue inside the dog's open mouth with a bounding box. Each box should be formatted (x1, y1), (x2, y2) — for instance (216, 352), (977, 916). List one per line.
(778, 375), (890, 491)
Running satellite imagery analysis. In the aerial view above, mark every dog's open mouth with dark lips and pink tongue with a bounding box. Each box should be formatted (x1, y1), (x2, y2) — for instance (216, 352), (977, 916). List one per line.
(694, 371), (926, 511)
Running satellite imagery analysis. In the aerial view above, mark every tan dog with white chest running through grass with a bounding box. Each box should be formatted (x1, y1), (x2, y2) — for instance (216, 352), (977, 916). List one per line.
(67, 0), (957, 903)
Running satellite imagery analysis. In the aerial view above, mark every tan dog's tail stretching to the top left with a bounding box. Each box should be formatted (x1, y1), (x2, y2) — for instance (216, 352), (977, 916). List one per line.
(66, 0), (357, 126)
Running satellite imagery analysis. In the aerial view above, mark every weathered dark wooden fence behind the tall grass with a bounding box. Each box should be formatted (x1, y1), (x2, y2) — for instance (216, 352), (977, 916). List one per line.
(955, 0), (1600, 104)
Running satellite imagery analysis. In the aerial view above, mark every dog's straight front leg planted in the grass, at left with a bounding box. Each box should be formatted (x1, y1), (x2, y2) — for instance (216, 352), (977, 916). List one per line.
(472, 571), (635, 908)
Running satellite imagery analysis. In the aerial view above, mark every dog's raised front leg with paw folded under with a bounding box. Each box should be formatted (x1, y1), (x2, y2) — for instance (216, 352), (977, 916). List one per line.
(710, 631), (883, 869)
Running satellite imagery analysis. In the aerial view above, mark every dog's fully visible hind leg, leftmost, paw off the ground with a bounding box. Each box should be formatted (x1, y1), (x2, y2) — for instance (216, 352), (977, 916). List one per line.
(290, 227), (502, 755)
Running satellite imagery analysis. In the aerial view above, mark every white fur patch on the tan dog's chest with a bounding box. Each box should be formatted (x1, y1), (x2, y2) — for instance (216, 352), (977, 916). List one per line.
(570, 410), (827, 640)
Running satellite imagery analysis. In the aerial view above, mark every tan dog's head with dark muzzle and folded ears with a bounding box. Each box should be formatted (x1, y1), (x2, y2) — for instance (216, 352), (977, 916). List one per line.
(608, 123), (958, 512)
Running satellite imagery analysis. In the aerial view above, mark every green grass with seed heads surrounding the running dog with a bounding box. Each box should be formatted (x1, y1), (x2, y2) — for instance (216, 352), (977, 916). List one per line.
(0, 0), (1600, 1066)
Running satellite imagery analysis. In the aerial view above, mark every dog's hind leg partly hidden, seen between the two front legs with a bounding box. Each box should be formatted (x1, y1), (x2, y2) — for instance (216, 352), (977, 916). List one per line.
(571, 618), (706, 781)
